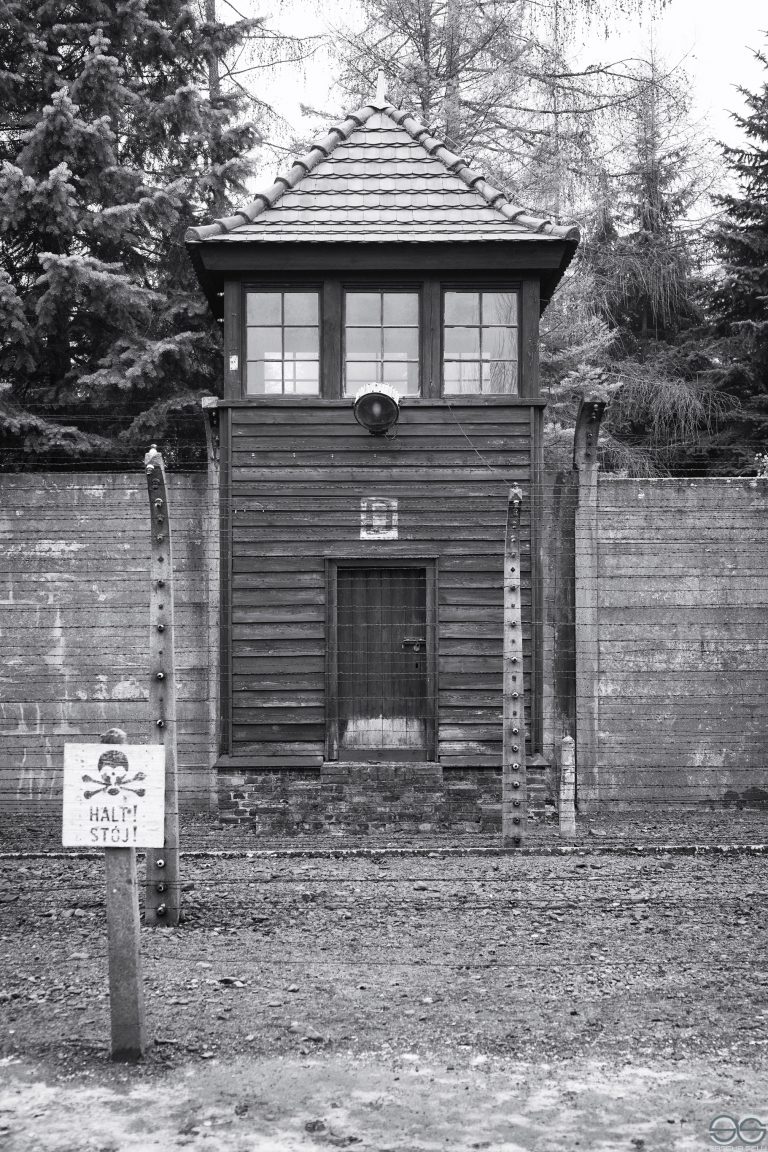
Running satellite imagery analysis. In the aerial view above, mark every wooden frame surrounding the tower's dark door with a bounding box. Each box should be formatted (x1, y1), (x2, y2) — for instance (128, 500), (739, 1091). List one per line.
(325, 552), (440, 761)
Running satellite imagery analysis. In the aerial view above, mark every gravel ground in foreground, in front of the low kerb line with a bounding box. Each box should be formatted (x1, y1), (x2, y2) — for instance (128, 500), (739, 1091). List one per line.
(0, 852), (768, 1152)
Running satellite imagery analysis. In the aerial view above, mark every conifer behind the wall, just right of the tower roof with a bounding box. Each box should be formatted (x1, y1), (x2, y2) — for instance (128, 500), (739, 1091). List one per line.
(542, 53), (731, 475)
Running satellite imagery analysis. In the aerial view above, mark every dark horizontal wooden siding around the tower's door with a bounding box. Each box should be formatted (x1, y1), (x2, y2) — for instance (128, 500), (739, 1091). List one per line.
(222, 399), (534, 766)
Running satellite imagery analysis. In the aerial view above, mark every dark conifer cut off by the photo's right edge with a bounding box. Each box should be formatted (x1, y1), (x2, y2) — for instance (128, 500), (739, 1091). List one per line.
(713, 42), (768, 472)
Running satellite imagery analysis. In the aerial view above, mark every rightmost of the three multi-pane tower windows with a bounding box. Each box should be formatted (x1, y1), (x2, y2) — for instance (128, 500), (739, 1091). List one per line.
(442, 291), (518, 395)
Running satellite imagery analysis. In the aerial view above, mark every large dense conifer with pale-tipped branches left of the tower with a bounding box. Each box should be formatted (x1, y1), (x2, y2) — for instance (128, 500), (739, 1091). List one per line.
(0, 0), (260, 468)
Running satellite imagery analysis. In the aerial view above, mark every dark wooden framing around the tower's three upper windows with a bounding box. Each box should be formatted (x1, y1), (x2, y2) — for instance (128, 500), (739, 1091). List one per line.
(237, 271), (540, 404)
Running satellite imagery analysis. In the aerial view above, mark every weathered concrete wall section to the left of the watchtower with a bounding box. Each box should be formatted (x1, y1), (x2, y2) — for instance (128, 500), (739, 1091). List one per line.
(0, 472), (218, 820)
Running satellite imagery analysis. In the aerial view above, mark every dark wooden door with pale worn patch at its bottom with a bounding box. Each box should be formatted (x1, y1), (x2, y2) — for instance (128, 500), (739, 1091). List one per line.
(336, 566), (433, 760)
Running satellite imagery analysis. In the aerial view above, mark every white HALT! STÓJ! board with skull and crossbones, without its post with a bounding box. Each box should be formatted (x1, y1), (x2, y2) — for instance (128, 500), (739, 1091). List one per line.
(61, 744), (166, 848)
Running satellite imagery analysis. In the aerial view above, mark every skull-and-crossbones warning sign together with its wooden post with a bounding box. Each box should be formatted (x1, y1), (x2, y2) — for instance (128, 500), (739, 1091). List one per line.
(61, 728), (165, 1061)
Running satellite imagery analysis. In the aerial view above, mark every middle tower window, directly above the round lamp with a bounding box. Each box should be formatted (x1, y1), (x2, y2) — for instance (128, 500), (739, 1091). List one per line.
(344, 291), (419, 396)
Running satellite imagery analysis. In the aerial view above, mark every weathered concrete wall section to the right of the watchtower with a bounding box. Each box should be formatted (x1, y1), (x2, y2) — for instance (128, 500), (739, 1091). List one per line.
(576, 476), (768, 808)
